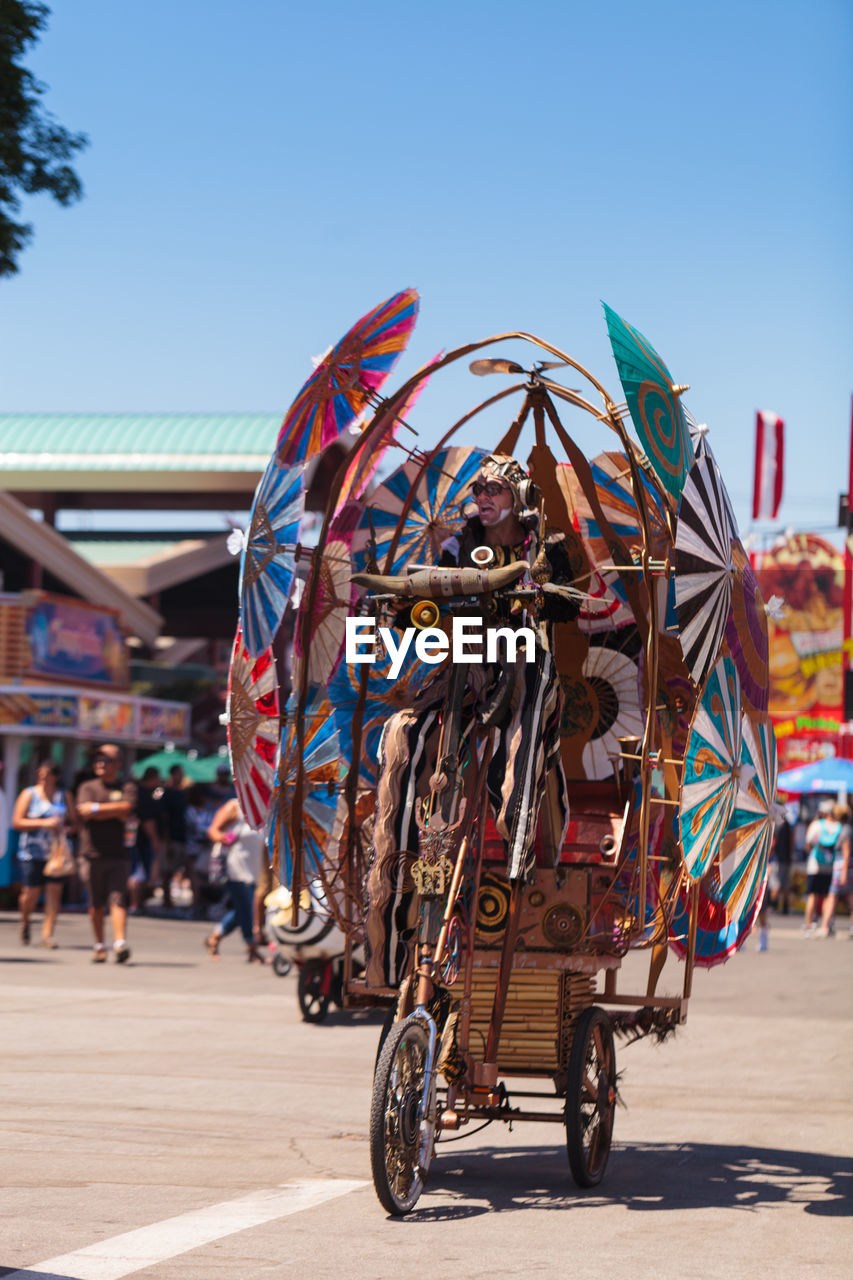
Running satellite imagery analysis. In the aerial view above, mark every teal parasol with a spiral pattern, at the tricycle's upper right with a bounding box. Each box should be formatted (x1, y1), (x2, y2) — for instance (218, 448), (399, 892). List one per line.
(603, 303), (693, 498)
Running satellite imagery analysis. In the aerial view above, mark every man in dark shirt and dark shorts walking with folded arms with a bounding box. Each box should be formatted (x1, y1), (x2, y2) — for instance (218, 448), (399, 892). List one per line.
(74, 742), (136, 964)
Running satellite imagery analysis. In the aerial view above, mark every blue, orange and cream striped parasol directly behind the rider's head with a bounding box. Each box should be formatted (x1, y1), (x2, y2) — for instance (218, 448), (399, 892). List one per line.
(352, 448), (487, 573)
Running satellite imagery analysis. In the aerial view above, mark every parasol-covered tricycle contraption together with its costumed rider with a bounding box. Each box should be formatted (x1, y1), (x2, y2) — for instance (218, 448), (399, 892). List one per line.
(229, 291), (776, 1215)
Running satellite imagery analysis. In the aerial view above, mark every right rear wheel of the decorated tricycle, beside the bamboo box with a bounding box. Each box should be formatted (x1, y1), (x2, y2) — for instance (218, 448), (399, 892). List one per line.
(566, 1005), (616, 1187)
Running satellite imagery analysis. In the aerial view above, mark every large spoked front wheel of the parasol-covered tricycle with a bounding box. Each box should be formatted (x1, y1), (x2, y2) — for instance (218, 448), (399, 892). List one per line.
(370, 1020), (435, 1217)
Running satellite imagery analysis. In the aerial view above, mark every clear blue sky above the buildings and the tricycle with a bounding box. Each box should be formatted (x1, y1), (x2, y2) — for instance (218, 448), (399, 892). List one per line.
(0, 0), (853, 527)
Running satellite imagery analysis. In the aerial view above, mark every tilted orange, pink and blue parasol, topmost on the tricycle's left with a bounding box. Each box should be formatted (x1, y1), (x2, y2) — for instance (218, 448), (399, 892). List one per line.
(275, 289), (418, 465)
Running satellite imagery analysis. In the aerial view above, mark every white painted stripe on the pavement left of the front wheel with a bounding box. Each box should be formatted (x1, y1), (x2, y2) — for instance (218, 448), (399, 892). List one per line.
(4, 1179), (366, 1280)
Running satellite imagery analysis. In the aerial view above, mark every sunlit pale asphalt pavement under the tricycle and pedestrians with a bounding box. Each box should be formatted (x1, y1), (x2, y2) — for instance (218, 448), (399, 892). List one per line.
(0, 914), (853, 1280)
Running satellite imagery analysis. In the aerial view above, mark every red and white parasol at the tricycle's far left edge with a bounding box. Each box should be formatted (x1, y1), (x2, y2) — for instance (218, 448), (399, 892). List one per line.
(225, 627), (280, 831)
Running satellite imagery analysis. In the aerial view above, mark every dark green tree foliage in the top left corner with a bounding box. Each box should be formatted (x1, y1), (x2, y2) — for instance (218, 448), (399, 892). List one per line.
(0, 0), (88, 275)
